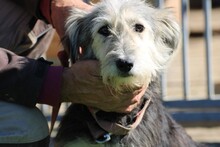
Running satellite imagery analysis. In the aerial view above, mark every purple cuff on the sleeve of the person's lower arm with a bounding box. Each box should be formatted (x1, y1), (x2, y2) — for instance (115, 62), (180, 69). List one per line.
(38, 66), (63, 106)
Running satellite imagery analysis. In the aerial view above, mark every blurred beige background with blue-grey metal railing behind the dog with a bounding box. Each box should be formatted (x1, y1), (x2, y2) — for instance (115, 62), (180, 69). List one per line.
(40, 0), (220, 146)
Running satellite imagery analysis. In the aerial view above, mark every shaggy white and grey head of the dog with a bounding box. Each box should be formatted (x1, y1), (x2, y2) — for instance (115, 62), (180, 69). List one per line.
(66, 0), (180, 91)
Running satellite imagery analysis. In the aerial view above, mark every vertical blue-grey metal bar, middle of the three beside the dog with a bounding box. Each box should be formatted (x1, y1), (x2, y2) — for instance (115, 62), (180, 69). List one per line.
(181, 0), (189, 99)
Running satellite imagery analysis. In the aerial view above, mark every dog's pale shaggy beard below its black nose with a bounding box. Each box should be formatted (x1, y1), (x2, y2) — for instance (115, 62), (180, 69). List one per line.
(100, 61), (152, 93)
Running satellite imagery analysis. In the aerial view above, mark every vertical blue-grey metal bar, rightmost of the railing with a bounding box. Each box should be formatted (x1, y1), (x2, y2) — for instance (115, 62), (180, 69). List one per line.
(203, 0), (214, 99)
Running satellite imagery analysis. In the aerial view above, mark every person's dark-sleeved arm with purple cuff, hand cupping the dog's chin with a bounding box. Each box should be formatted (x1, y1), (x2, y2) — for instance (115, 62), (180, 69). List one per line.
(0, 48), (144, 112)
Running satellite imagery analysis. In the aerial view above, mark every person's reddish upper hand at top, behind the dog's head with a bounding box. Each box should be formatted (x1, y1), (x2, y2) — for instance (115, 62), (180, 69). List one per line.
(51, 0), (92, 38)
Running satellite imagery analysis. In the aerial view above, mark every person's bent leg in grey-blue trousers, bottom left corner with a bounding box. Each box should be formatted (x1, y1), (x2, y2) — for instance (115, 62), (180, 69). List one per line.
(0, 101), (49, 147)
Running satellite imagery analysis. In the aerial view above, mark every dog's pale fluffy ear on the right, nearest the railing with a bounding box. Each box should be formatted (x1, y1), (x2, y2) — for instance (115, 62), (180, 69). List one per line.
(154, 8), (181, 50)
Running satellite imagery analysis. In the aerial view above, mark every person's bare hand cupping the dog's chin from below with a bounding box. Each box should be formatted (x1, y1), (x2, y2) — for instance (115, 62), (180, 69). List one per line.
(61, 60), (146, 113)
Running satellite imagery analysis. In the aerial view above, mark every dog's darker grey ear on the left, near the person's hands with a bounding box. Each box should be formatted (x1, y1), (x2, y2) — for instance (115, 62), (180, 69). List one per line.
(65, 9), (88, 63)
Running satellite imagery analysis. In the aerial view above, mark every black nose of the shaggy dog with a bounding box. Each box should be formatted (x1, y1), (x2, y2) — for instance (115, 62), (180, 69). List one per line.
(116, 59), (133, 73)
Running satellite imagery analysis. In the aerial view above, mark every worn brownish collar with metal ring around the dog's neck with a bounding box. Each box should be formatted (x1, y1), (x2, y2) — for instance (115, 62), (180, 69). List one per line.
(87, 98), (151, 143)
